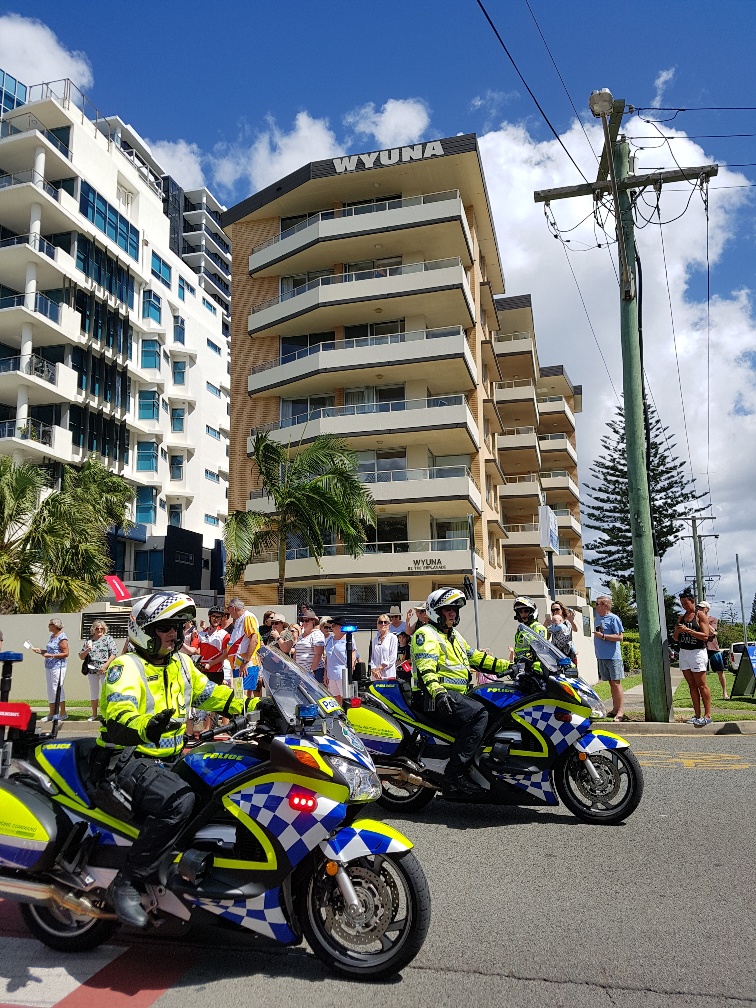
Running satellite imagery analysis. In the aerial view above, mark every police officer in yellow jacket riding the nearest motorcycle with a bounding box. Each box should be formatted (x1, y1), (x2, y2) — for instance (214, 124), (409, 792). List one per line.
(93, 592), (244, 927)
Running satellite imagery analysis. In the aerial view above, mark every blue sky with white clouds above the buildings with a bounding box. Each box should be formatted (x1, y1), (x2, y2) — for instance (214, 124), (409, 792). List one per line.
(0, 0), (756, 617)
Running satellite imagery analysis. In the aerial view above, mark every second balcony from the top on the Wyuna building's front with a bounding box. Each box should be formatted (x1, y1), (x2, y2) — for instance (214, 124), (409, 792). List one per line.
(249, 257), (475, 336)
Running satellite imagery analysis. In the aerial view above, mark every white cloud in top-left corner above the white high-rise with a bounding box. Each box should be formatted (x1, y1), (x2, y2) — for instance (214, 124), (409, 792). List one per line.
(0, 14), (94, 91)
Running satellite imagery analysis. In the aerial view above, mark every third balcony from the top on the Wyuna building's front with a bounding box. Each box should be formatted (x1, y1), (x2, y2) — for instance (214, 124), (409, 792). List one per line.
(248, 326), (476, 396)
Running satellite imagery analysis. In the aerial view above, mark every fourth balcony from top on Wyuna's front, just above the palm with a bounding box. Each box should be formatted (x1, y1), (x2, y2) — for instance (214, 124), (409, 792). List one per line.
(255, 395), (480, 455)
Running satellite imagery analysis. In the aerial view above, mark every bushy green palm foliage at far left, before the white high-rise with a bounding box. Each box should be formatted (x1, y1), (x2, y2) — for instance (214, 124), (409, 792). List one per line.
(0, 458), (134, 613)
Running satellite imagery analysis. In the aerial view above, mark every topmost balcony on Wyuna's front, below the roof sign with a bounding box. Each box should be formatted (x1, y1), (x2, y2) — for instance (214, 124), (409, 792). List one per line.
(249, 190), (473, 275)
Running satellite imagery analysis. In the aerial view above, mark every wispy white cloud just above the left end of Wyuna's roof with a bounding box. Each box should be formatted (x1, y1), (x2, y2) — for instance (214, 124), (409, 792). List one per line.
(211, 112), (342, 192)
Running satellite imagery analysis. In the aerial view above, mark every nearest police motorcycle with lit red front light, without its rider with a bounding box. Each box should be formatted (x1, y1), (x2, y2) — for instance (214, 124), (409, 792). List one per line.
(0, 647), (430, 979)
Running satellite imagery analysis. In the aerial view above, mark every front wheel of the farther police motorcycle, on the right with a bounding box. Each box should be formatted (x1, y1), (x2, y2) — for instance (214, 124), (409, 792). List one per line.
(554, 748), (643, 826)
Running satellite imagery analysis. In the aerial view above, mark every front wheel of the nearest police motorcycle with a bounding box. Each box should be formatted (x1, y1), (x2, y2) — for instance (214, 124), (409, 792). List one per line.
(297, 852), (430, 980)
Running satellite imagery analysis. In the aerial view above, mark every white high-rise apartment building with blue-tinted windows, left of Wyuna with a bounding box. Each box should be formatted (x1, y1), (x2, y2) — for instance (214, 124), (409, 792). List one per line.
(0, 73), (231, 592)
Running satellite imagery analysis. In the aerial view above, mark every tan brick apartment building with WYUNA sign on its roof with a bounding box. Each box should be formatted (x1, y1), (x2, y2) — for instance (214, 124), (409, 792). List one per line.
(223, 134), (582, 606)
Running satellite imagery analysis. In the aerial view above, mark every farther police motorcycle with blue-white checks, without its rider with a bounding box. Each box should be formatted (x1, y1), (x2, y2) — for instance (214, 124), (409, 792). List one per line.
(348, 623), (643, 825)
